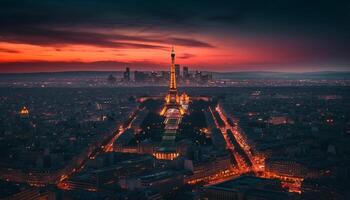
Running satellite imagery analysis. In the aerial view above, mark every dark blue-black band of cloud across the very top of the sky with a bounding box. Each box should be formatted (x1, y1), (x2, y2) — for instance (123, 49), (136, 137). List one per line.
(0, 0), (350, 31)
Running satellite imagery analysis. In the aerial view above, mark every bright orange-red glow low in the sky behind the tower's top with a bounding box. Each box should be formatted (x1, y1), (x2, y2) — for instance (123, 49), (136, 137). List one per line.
(0, 32), (344, 73)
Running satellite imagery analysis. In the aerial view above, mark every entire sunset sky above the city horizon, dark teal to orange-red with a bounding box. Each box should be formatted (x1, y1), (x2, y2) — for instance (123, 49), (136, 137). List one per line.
(0, 0), (350, 73)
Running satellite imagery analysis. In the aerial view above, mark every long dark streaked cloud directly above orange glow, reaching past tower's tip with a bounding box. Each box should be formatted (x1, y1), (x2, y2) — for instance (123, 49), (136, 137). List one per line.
(0, 28), (213, 49)
